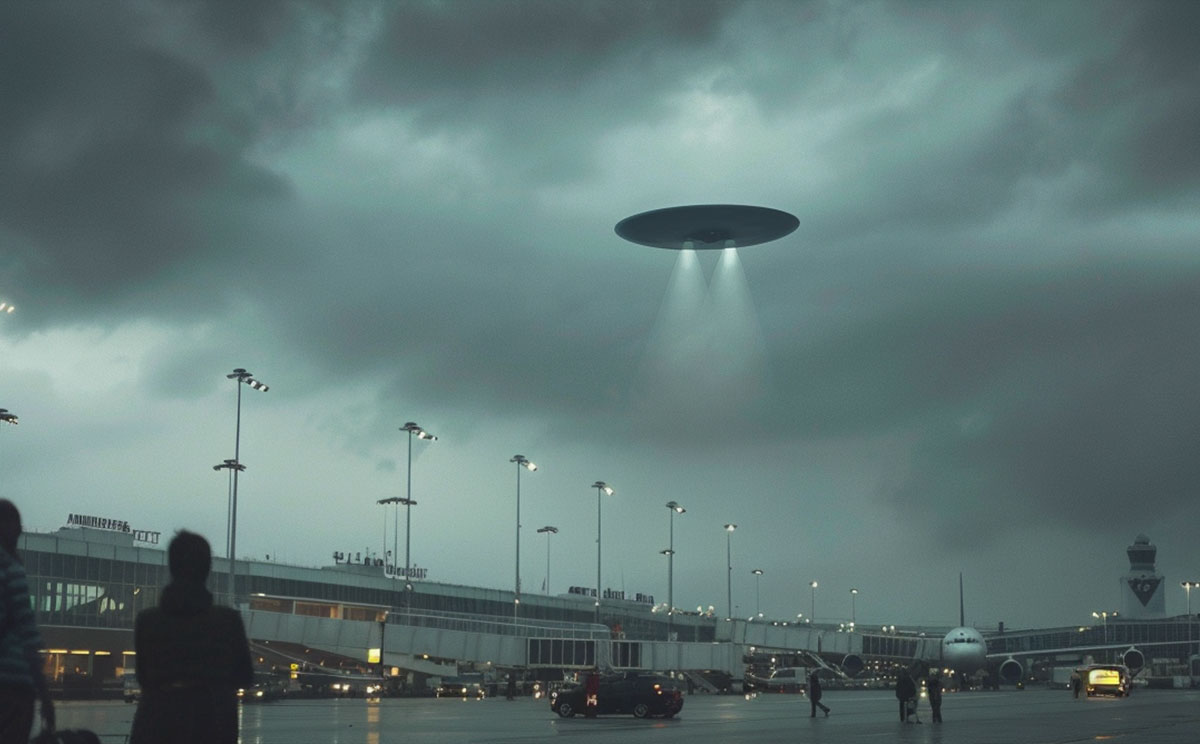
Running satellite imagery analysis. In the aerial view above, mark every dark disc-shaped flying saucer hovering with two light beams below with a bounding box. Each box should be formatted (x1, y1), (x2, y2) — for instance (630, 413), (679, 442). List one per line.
(614, 204), (800, 251)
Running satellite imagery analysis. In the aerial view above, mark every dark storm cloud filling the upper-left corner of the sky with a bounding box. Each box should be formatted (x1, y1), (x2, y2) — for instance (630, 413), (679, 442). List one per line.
(0, 4), (287, 317)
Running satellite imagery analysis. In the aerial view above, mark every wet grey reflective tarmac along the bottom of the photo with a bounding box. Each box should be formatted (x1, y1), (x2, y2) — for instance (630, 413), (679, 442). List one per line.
(49, 689), (1200, 744)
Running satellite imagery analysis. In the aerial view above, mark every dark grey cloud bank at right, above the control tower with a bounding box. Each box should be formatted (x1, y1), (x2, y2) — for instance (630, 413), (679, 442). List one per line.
(790, 262), (1200, 546)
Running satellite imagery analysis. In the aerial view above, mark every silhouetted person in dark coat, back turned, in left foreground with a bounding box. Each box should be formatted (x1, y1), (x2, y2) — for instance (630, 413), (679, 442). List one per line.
(130, 530), (254, 744)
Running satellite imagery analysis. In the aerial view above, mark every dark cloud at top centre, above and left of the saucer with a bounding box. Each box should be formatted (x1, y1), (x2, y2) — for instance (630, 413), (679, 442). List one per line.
(355, 0), (739, 182)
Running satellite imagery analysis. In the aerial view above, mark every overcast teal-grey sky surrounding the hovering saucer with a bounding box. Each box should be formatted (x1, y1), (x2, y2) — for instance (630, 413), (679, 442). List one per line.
(0, 0), (1200, 626)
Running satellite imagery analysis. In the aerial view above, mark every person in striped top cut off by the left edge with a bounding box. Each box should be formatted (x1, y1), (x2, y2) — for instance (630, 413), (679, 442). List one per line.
(0, 499), (54, 744)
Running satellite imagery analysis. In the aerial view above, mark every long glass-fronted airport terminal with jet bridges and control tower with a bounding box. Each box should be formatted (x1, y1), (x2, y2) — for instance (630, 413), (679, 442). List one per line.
(19, 523), (1200, 692)
